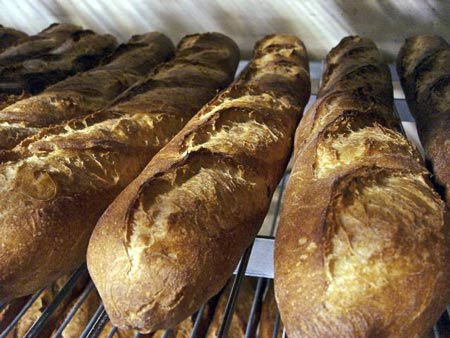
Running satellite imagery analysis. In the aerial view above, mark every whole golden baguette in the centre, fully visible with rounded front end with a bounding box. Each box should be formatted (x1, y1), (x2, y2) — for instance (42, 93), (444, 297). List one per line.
(88, 35), (310, 332)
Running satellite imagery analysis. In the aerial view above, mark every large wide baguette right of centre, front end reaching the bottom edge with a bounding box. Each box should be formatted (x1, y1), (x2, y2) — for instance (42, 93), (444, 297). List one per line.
(275, 37), (450, 338)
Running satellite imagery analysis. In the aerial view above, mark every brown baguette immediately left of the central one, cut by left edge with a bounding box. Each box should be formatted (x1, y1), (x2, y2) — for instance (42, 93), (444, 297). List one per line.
(0, 33), (239, 300)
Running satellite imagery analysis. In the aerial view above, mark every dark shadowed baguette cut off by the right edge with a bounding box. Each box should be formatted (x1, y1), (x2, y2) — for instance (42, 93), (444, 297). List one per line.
(397, 35), (450, 206)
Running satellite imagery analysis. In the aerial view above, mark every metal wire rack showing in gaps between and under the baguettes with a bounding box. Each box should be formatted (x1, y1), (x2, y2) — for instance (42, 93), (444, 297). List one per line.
(0, 61), (450, 338)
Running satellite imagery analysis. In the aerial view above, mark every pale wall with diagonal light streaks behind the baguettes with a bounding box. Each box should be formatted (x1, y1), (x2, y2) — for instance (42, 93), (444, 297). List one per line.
(0, 0), (450, 60)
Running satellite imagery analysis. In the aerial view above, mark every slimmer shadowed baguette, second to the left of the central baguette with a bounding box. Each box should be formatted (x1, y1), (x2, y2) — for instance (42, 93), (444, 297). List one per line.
(0, 33), (174, 150)
